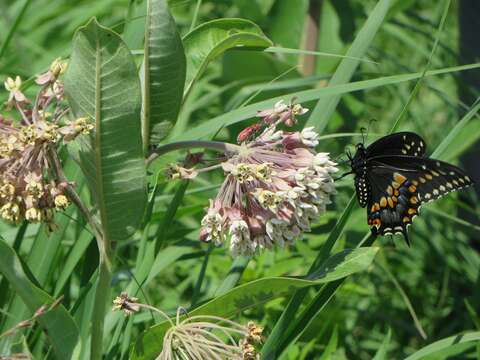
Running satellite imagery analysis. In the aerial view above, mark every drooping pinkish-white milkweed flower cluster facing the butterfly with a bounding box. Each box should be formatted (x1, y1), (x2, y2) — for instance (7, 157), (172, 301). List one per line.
(200, 98), (337, 256)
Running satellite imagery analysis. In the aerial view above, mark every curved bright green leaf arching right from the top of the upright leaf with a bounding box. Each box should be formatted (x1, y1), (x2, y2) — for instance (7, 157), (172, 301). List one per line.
(183, 19), (272, 94)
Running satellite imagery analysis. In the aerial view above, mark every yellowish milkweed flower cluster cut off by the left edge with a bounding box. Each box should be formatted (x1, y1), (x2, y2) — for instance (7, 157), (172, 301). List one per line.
(0, 60), (93, 230)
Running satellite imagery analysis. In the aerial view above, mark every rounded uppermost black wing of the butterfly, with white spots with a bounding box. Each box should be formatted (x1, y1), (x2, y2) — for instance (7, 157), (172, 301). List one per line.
(367, 131), (427, 158)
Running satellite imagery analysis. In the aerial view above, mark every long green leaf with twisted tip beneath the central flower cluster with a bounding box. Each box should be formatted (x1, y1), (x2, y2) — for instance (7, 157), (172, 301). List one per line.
(132, 247), (378, 359)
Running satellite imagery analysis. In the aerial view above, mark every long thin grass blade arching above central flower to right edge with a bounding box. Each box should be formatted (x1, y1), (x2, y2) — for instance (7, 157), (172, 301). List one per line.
(172, 63), (480, 141)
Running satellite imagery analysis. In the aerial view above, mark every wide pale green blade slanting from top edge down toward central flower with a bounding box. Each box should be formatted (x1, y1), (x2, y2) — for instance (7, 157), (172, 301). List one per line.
(307, 0), (391, 133)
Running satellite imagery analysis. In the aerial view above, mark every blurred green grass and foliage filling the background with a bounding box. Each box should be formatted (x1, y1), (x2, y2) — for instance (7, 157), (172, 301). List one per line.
(0, 0), (480, 360)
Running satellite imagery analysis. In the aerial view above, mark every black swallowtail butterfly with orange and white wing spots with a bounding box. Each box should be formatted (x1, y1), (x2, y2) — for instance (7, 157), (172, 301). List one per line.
(349, 132), (472, 245)
